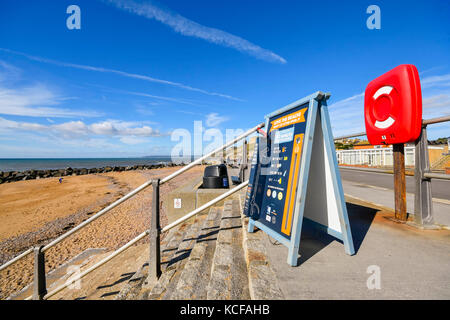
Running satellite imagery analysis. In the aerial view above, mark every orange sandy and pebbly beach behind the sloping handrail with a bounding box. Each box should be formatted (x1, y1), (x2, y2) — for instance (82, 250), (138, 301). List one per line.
(0, 166), (203, 299)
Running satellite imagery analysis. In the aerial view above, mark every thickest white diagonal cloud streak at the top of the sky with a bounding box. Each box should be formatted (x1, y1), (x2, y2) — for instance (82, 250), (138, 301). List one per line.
(105, 0), (286, 64)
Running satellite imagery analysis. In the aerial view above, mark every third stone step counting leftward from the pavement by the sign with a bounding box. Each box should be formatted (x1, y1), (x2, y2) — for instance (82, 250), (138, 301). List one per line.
(163, 207), (222, 300)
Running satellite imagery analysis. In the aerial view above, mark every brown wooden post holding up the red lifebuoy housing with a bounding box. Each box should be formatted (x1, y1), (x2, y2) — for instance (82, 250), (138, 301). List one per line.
(393, 143), (407, 221)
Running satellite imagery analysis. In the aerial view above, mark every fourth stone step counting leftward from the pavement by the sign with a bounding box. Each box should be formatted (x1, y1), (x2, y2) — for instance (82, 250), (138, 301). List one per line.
(145, 215), (206, 300)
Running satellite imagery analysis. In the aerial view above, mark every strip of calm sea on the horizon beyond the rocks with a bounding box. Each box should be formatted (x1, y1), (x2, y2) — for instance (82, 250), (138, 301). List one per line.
(0, 156), (186, 171)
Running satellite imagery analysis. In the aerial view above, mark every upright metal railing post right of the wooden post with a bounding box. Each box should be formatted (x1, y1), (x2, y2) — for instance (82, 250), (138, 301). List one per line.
(414, 125), (434, 227)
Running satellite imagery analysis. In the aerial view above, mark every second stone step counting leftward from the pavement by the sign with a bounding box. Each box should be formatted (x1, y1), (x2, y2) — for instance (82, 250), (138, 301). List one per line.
(206, 200), (250, 300)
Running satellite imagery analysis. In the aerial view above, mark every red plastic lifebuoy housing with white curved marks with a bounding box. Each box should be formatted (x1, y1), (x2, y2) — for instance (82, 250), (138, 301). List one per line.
(364, 64), (422, 145)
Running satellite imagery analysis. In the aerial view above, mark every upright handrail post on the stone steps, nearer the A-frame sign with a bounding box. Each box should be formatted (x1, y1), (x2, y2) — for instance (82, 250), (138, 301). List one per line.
(148, 179), (161, 280)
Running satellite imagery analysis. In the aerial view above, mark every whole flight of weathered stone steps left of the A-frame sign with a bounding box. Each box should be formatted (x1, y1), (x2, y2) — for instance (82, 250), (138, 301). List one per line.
(116, 199), (284, 300)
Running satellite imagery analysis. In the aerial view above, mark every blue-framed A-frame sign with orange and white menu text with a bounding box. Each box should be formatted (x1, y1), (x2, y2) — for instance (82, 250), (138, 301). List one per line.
(244, 91), (355, 266)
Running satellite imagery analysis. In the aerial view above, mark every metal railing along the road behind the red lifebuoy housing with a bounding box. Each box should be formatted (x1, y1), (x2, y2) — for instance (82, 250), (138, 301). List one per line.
(334, 116), (450, 227)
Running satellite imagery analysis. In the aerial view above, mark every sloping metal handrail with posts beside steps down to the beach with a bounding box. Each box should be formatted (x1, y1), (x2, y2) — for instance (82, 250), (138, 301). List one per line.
(0, 123), (265, 300)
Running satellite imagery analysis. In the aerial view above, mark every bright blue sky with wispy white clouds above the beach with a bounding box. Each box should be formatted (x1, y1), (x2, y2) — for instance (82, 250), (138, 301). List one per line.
(0, 0), (450, 158)
